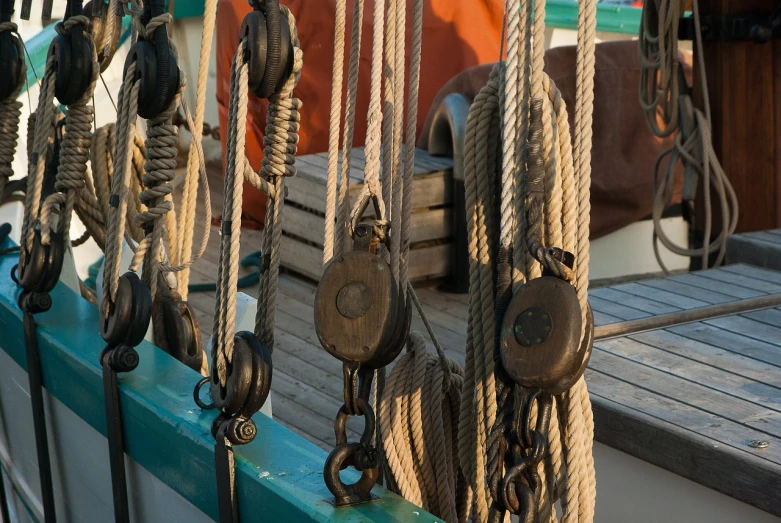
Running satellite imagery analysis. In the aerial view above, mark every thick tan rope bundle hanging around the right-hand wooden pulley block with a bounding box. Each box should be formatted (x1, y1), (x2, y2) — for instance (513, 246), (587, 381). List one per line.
(459, 0), (596, 522)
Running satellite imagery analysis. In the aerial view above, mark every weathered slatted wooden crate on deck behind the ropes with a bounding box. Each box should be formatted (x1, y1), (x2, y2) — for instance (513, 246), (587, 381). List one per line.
(281, 148), (453, 281)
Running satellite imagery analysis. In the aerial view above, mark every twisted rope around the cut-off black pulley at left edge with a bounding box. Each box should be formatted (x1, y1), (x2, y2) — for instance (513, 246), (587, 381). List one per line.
(0, 22), (27, 207)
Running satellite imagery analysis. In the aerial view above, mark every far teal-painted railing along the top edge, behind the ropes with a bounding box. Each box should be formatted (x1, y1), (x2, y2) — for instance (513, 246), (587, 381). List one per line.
(169, 0), (641, 34)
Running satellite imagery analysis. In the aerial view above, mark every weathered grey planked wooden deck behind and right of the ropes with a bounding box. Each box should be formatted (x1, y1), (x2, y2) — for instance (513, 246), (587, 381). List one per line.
(189, 167), (781, 515)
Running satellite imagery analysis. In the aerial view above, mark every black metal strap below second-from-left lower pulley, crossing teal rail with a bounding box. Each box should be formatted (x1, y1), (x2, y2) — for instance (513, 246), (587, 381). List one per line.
(103, 357), (130, 523)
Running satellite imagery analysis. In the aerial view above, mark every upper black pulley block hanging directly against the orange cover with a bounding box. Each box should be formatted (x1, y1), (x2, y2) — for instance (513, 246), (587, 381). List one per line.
(239, 1), (293, 98)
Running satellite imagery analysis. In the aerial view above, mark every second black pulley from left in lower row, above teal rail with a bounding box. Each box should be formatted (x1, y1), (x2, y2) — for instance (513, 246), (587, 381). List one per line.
(100, 272), (152, 347)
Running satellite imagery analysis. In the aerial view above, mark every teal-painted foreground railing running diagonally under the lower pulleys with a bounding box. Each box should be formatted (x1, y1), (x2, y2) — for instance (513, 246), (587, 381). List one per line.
(0, 243), (437, 523)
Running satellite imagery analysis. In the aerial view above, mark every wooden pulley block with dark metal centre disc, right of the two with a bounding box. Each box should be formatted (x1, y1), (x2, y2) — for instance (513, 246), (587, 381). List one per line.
(500, 276), (594, 394)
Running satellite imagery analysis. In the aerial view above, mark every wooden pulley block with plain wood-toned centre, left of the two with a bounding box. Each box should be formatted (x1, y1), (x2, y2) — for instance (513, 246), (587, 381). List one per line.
(315, 224), (411, 369)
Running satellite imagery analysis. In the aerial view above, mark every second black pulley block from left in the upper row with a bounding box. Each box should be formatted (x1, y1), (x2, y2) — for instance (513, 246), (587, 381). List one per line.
(49, 21), (92, 105)
